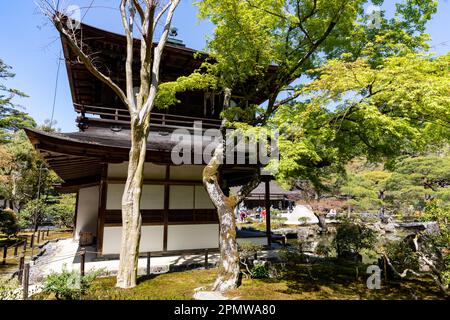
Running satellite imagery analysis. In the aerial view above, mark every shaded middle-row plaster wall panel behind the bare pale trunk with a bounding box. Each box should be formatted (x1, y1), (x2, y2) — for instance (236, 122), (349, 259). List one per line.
(106, 183), (164, 210)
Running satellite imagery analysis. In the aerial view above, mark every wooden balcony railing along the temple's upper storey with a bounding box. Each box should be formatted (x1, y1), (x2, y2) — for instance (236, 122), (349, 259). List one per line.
(74, 104), (222, 130)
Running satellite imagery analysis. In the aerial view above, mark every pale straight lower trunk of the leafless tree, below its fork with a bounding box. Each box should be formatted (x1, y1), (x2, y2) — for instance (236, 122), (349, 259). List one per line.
(116, 125), (147, 288)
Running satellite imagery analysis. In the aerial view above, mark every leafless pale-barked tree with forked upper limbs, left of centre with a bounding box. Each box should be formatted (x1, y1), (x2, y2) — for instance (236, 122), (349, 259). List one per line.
(40, 0), (180, 288)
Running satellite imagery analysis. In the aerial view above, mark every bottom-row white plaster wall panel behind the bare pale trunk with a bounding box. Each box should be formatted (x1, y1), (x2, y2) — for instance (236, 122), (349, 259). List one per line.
(103, 226), (164, 254)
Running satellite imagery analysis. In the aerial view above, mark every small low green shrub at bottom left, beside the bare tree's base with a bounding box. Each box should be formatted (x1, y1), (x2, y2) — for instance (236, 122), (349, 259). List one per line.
(43, 266), (102, 300)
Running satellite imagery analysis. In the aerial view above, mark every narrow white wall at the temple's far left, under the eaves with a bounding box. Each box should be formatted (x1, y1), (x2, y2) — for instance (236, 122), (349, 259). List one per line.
(75, 186), (99, 239)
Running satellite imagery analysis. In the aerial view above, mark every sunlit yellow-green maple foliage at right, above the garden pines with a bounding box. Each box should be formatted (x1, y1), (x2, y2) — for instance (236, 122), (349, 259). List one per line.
(271, 54), (450, 192)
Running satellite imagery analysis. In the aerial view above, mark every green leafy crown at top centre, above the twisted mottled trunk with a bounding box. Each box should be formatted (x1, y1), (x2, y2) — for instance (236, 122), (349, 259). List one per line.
(197, 0), (437, 90)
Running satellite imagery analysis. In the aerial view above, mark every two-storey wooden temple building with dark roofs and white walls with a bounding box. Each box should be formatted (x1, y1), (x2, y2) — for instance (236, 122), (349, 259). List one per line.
(26, 24), (278, 255)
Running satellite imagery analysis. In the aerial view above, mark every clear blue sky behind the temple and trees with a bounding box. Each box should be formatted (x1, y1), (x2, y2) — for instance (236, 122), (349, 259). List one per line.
(0, 0), (450, 132)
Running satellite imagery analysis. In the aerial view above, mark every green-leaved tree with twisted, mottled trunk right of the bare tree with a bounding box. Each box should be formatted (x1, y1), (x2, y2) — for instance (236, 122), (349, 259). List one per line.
(197, 0), (436, 291)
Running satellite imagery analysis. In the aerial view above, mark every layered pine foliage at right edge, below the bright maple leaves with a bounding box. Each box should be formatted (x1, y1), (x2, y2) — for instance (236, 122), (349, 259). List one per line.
(340, 149), (450, 215)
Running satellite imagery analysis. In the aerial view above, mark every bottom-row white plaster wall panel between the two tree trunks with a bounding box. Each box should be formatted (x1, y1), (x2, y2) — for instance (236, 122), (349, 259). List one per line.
(167, 224), (219, 251)
